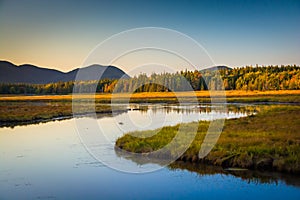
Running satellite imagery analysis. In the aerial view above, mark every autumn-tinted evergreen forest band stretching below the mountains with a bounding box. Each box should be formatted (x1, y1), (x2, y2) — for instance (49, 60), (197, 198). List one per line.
(0, 65), (300, 95)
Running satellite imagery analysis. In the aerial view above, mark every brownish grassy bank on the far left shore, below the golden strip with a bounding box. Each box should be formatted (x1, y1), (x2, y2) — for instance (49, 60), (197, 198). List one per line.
(0, 100), (126, 127)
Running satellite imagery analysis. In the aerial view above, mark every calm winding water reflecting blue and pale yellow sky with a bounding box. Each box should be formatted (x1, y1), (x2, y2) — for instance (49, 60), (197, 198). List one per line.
(0, 105), (300, 199)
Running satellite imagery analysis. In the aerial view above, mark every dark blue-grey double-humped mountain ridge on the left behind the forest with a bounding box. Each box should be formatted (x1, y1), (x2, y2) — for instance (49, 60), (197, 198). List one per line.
(0, 61), (130, 84)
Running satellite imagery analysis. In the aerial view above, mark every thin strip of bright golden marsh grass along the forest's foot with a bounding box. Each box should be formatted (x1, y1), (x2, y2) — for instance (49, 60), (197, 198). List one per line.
(0, 90), (300, 103)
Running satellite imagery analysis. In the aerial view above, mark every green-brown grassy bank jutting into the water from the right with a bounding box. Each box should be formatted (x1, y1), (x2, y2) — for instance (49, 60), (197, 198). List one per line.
(116, 105), (300, 174)
